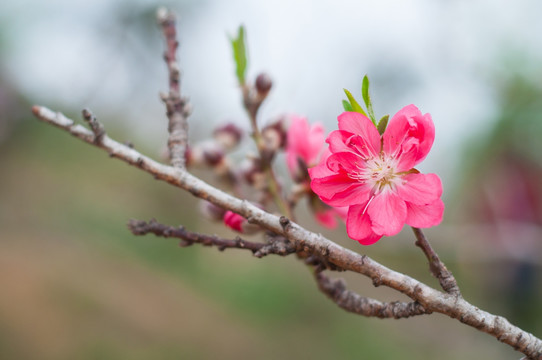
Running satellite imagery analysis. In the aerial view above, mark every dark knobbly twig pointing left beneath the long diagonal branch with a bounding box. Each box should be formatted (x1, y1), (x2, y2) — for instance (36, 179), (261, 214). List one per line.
(128, 219), (296, 258)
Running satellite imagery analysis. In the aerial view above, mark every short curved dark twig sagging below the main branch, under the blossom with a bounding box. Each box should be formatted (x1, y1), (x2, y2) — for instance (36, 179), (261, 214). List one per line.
(314, 271), (431, 319)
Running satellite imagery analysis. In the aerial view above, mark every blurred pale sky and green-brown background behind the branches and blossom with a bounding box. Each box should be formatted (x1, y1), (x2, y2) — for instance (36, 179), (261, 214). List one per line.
(0, 0), (542, 359)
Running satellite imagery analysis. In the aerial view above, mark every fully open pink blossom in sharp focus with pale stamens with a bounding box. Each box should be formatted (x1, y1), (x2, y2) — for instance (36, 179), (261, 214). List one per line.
(309, 105), (444, 245)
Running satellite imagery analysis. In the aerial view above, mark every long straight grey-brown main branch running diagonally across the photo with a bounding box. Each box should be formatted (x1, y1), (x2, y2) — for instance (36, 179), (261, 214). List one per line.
(32, 106), (542, 360)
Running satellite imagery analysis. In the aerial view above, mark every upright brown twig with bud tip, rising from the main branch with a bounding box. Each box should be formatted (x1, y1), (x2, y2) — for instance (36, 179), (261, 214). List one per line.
(157, 8), (190, 169)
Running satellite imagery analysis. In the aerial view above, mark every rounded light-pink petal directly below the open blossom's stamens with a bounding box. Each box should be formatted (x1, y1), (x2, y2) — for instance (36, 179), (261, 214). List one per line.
(367, 190), (407, 236)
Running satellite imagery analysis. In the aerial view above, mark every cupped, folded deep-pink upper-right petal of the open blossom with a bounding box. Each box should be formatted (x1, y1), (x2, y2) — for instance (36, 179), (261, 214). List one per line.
(383, 105), (435, 167)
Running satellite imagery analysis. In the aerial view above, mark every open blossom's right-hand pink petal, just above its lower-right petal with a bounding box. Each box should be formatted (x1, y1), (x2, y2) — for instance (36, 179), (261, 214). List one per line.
(397, 174), (442, 205)
